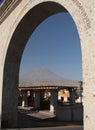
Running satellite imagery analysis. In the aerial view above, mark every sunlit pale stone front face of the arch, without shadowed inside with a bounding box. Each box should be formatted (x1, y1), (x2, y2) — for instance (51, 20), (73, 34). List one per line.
(0, 0), (95, 130)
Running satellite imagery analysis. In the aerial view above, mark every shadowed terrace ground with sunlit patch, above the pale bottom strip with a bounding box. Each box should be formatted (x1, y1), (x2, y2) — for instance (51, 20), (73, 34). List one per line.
(18, 108), (83, 128)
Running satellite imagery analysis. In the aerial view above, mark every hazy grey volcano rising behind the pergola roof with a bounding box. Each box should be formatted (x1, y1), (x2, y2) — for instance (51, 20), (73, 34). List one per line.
(19, 67), (79, 87)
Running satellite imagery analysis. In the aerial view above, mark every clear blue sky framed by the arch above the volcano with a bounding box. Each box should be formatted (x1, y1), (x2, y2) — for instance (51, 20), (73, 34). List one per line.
(20, 13), (82, 80)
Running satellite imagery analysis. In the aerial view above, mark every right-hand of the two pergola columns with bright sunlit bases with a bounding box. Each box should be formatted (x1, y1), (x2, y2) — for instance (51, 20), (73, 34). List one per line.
(50, 90), (58, 113)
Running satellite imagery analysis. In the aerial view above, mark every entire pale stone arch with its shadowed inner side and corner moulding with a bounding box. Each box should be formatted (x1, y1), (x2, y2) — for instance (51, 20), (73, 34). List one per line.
(0, 0), (95, 130)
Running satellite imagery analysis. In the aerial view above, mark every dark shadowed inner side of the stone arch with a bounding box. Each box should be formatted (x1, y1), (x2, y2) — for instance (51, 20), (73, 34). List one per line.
(2, 2), (83, 128)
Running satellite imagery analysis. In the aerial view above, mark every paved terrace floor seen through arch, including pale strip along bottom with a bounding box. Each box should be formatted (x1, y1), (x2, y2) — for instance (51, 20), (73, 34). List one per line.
(3, 107), (83, 130)
